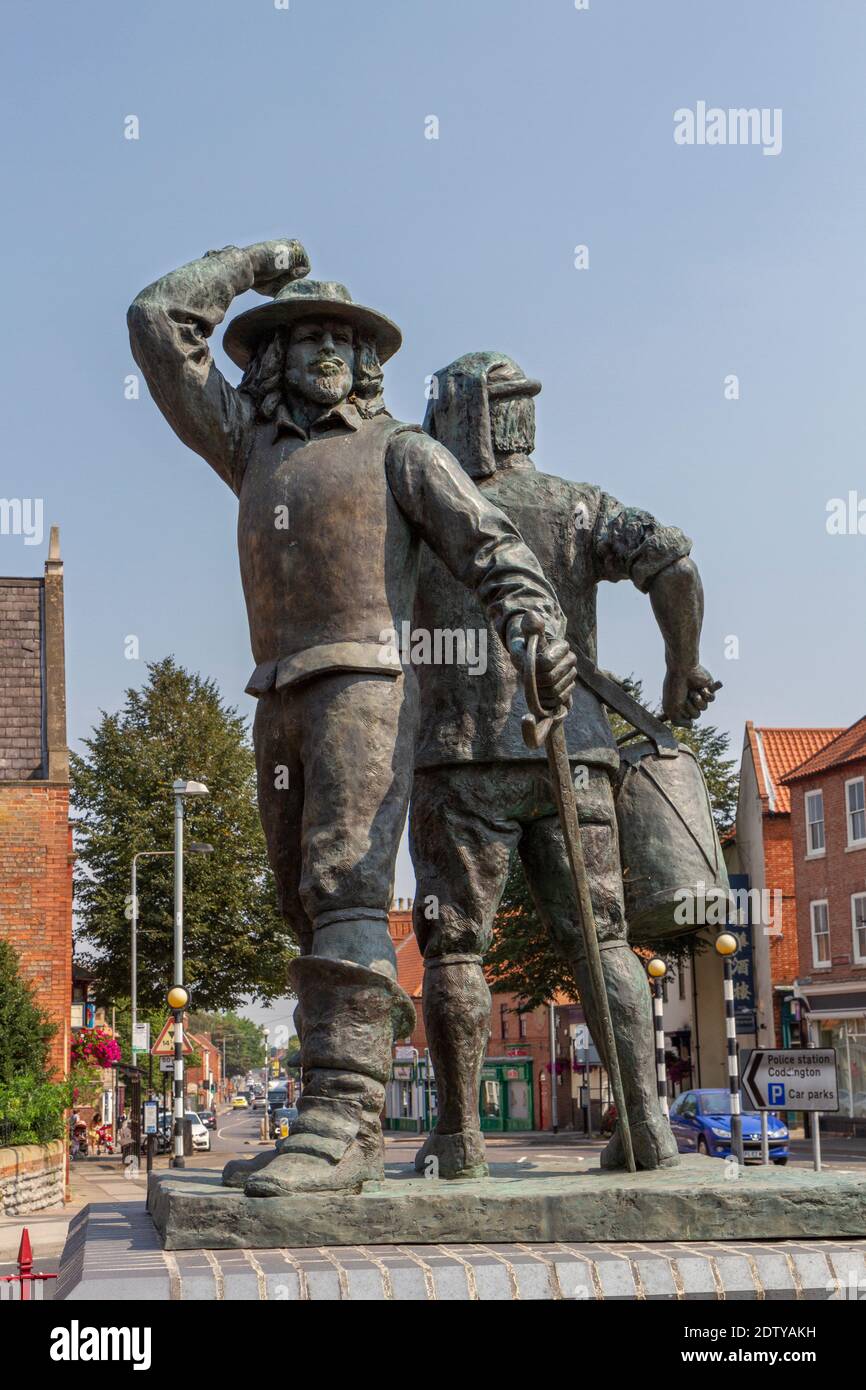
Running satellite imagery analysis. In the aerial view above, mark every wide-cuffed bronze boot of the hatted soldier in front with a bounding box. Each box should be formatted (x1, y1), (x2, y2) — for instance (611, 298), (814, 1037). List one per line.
(245, 956), (414, 1197)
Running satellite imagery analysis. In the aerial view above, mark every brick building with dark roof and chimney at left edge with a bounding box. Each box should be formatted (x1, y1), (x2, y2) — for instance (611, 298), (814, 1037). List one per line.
(0, 527), (72, 1076)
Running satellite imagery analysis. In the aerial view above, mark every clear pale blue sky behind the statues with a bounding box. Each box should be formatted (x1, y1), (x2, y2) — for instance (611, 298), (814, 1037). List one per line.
(0, 0), (866, 1016)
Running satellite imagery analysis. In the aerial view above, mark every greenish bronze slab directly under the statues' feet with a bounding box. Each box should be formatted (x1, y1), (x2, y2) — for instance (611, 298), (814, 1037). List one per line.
(147, 1156), (866, 1250)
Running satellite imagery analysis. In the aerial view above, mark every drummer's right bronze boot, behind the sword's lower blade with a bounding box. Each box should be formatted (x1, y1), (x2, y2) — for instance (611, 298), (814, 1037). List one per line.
(571, 941), (680, 1169)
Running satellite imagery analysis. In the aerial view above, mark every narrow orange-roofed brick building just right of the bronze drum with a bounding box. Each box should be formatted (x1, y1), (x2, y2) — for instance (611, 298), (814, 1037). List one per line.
(728, 720), (840, 1045)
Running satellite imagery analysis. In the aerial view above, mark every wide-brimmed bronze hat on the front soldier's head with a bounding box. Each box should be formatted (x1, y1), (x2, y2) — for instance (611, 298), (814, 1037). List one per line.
(222, 279), (403, 368)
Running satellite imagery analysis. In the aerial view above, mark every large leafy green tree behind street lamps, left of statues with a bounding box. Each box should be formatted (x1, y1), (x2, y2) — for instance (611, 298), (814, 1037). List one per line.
(71, 657), (295, 1009)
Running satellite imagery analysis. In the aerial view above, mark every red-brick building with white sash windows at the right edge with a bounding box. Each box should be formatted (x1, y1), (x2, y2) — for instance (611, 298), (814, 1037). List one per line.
(784, 717), (866, 1134)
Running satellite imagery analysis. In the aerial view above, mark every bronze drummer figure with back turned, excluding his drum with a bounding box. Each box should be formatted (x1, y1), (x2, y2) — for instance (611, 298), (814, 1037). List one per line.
(410, 352), (714, 1177)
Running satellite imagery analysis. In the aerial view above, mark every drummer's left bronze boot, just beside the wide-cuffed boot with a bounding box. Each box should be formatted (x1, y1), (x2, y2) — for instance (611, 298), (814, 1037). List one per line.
(416, 956), (491, 1177)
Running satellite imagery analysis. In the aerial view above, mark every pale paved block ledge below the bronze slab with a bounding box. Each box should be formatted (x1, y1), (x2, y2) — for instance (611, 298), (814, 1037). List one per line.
(54, 1202), (866, 1304)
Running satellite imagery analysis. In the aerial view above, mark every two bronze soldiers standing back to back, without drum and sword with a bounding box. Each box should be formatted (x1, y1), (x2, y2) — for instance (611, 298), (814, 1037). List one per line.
(129, 240), (712, 1197)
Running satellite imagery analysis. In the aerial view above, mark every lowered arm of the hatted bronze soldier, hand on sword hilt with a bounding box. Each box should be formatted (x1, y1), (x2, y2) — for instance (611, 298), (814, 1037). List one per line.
(386, 431), (575, 706)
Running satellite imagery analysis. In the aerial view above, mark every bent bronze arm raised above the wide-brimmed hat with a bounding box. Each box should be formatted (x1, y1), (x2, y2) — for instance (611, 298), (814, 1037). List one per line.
(126, 240), (309, 491)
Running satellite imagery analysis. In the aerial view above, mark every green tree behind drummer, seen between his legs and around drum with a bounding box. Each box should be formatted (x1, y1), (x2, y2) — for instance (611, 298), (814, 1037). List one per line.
(485, 680), (738, 1009)
